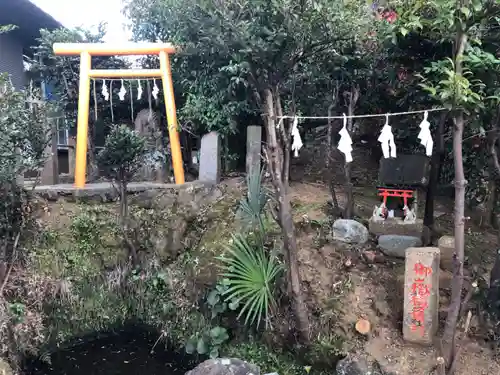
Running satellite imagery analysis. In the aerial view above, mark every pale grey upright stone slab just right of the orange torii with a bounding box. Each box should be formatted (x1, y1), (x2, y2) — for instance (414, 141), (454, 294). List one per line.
(198, 132), (221, 183)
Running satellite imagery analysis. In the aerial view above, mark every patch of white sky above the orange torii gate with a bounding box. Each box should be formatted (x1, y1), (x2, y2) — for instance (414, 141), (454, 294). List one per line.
(31, 0), (131, 43)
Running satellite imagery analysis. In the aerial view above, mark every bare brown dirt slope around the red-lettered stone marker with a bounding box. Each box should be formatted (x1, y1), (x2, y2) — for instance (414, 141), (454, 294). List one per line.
(290, 179), (500, 375)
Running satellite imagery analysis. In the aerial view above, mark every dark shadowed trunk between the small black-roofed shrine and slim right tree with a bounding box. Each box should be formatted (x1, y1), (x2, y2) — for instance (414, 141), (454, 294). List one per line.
(422, 112), (448, 245)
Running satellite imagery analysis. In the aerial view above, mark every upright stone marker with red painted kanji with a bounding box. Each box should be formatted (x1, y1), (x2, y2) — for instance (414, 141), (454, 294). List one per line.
(403, 247), (439, 345)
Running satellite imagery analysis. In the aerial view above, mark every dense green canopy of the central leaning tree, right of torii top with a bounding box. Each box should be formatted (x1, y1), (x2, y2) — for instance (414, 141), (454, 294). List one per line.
(126, 0), (376, 132)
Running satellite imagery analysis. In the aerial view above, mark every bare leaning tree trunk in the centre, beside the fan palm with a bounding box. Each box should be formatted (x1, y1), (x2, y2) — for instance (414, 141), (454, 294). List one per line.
(263, 89), (309, 342)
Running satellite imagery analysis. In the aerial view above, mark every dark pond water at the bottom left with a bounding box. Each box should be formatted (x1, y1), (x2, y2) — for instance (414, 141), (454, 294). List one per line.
(24, 326), (199, 375)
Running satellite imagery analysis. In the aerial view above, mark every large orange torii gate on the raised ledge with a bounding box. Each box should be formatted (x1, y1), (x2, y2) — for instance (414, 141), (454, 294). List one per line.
(53, 43), (184, 188)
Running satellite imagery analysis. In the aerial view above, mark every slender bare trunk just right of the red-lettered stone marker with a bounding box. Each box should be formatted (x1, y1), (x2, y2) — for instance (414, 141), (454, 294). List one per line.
(443, 30), (467, 375)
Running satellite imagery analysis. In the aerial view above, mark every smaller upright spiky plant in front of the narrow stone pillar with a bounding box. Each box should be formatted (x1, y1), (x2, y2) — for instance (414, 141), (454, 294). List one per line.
(237, 169), (269, 232)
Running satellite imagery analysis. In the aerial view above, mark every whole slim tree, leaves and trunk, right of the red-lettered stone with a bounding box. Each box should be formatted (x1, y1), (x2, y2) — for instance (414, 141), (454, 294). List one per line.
(394, 0), (500, 374)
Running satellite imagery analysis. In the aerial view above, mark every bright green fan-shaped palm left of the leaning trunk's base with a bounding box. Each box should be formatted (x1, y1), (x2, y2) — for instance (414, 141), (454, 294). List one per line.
(219, 234), (283, 328)
